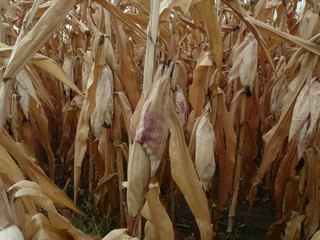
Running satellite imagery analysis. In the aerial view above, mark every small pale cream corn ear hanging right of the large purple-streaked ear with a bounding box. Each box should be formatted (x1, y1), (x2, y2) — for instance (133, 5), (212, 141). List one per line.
(195, 113), (216, 191)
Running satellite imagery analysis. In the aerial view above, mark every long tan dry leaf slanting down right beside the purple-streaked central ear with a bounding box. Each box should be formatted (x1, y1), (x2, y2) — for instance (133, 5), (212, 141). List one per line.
(168, 103), (213, 240)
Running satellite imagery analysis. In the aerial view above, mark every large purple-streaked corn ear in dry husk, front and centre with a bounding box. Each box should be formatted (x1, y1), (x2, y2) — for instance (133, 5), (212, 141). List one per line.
(127, 62), (173, 236)
